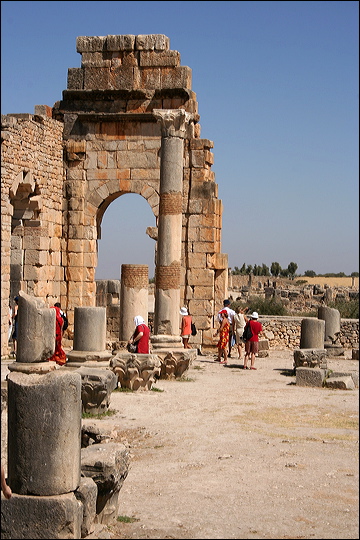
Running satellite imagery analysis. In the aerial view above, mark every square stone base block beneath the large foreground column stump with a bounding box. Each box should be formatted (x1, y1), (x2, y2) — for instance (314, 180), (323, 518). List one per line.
(1, 493), (83, 540)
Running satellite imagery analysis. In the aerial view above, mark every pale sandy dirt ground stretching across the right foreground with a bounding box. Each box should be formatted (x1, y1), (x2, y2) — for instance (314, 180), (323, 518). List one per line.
(86, 351), (359, 539)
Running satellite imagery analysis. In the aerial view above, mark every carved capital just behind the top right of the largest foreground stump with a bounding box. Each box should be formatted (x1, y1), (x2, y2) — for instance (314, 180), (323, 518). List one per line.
(74, 366), (117, 414)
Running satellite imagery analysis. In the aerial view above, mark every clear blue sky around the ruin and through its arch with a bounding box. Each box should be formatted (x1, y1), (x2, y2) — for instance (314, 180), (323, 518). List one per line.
(1, 1), (359, 279)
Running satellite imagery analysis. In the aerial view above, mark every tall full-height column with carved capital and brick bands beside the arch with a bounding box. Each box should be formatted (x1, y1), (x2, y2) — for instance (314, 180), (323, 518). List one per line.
(152, 109), (191, 347)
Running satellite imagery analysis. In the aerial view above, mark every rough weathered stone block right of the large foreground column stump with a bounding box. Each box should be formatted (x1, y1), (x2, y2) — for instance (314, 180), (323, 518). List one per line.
(81, 442), (130, 525)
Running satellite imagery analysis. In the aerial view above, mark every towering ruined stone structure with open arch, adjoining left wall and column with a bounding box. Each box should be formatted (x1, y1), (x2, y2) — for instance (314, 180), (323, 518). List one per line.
(1, 35), (228, 355)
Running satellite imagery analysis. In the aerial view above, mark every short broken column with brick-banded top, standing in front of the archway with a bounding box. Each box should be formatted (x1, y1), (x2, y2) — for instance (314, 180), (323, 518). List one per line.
(119, 264), (149, 341)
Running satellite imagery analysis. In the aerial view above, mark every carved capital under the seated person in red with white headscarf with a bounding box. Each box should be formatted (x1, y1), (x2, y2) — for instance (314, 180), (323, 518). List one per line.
(110, 352), (161, 391)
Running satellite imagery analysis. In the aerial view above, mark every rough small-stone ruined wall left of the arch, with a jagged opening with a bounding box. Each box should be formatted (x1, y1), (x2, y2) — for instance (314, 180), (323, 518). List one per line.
(1, 111), (64, 355)
